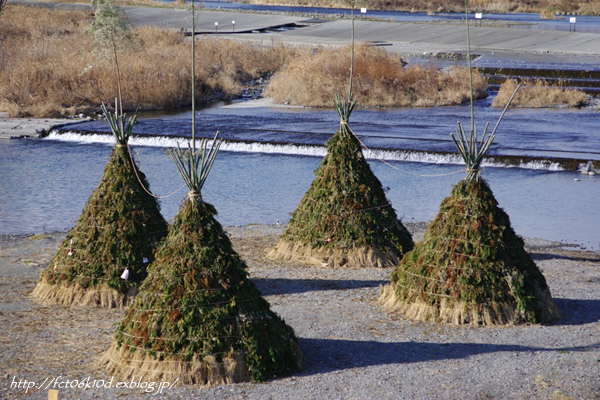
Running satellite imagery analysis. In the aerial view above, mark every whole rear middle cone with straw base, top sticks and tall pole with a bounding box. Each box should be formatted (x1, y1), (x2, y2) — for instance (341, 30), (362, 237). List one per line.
(269, 1), (414, 268)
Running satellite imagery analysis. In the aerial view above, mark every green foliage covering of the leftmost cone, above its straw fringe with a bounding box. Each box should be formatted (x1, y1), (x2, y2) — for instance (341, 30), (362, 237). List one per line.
(42, 146), (168, 293)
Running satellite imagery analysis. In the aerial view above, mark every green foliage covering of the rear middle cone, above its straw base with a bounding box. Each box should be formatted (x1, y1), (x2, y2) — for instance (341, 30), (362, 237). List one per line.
(282, 123), (413, 257)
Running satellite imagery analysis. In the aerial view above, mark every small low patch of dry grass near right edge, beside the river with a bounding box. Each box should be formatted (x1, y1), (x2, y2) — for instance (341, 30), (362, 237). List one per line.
(492, 79), (590, 108)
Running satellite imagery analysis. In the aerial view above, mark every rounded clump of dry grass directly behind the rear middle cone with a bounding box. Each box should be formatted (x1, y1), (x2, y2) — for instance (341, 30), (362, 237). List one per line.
(265, 44), (487, 107)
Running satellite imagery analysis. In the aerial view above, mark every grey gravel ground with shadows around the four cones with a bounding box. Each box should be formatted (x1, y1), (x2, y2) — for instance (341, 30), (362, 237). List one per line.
(0, 224), (600, 399)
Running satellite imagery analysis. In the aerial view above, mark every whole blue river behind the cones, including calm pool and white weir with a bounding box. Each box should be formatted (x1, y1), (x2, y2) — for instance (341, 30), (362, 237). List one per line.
(0, 100), (600, 249)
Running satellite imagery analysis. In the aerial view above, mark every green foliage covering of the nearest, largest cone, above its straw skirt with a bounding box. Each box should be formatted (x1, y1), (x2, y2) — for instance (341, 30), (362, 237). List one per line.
(117, 199), (301, 381)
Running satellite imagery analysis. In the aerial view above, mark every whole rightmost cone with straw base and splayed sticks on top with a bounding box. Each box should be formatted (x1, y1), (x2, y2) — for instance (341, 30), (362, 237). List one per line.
(379, 1), (560, 326)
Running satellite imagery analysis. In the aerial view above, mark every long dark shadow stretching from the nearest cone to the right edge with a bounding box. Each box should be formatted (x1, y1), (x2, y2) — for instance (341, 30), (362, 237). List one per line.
(299, 338), (600, 375)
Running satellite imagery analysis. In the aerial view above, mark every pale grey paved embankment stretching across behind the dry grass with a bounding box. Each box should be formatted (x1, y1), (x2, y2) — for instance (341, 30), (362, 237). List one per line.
(16, 0), (600, 58)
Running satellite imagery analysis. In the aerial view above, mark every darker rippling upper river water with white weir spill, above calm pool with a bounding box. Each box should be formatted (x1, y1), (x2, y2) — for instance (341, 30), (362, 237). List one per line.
(51, 96), (600, 170)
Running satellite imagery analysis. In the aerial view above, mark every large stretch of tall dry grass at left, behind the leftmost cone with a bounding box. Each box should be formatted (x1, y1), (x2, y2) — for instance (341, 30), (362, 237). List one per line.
(0, 5), (292, 117)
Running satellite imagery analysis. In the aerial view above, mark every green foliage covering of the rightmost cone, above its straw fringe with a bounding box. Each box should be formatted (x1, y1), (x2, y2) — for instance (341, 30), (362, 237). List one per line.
(392, 179), (554, 323)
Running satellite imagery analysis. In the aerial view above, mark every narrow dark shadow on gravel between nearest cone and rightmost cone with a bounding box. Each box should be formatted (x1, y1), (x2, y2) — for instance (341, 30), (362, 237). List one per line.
(252, 278), (388, 296)
